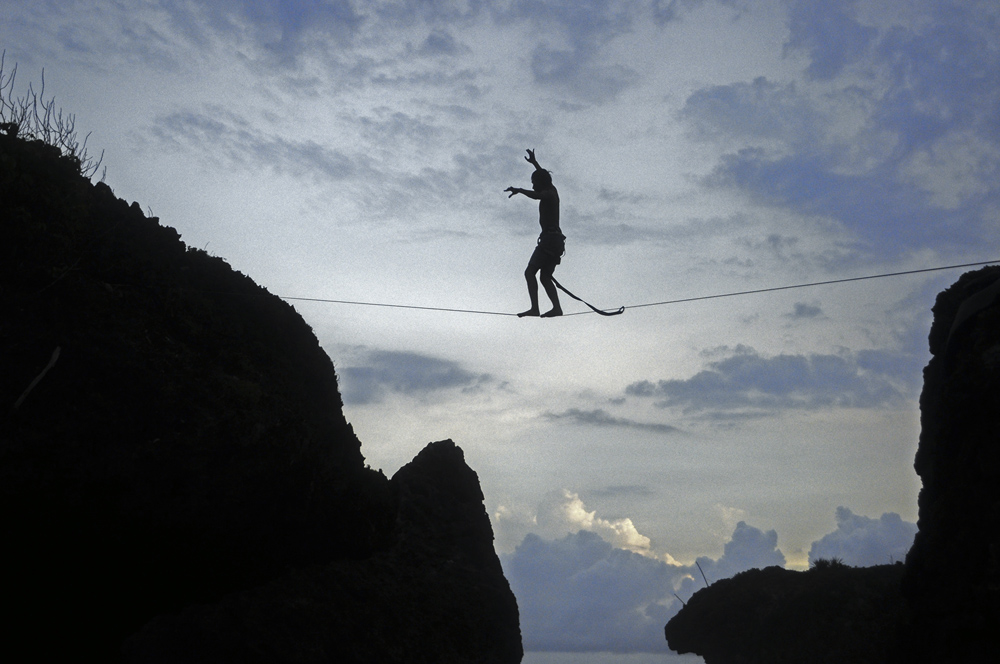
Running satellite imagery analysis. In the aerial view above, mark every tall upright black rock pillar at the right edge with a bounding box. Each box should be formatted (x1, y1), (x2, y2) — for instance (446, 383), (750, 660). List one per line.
(899, 267), (1000, 663)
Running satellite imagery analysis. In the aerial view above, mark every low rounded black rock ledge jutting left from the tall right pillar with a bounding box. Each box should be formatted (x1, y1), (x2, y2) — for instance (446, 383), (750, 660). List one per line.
(664, 563), (903, 664)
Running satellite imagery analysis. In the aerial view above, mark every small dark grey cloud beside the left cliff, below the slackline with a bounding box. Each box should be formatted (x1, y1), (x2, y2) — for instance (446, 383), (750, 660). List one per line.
(337, 350), (493, 405)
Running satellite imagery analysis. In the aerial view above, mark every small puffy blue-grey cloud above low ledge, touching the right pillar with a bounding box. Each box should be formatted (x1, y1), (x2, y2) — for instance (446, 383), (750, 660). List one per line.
(809, 507), (917, 567)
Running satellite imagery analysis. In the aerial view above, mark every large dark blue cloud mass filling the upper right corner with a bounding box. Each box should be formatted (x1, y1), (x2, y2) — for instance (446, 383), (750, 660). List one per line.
(680, 0), (1000, 258)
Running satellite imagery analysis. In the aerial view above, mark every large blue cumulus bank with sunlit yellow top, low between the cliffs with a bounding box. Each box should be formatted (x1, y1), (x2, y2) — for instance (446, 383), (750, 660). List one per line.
(500, 504), (784, 653)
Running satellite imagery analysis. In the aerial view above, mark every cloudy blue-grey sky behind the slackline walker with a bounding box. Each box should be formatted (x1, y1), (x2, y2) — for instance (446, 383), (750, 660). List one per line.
(0, 0), (1000, 664)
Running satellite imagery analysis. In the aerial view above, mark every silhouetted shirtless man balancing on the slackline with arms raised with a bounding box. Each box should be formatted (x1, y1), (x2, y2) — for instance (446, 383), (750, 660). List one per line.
(504, 150), (566, 318)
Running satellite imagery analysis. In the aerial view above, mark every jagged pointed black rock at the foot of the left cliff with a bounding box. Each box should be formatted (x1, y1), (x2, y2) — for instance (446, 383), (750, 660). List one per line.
(125, 440), (521, 664)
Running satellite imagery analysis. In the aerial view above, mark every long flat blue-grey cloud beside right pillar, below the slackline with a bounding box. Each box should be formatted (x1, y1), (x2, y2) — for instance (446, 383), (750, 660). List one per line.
(625, 346), (917, 414)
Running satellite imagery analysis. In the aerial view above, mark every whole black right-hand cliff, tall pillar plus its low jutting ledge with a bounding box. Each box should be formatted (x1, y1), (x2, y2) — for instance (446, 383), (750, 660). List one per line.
(665, 267), (1000, 664)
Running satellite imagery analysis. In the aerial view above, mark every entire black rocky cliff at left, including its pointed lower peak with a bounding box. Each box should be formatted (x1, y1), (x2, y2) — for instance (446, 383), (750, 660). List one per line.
(0, 133), (521, 662)
